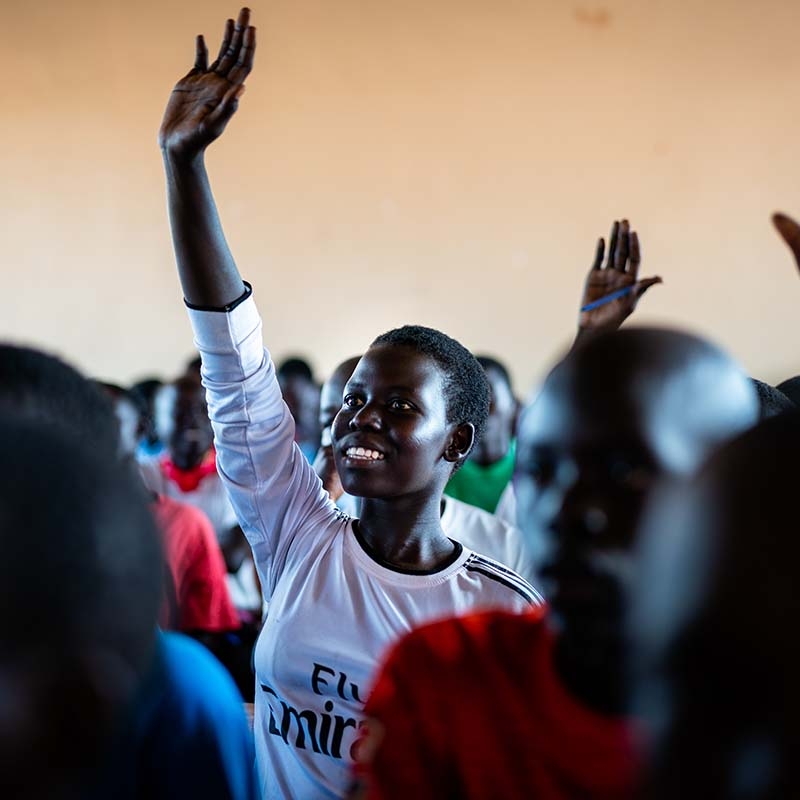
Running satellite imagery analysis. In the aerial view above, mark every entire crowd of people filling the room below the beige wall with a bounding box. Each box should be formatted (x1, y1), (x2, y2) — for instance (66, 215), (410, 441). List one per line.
(7, 3), (800, 800)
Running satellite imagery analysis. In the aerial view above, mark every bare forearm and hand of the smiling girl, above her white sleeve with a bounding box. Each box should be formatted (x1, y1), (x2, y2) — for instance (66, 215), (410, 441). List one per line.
(158, 8), (256, 308)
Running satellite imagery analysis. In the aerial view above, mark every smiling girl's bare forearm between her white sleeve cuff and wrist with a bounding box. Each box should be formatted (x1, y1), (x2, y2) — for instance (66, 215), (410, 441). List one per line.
(162, 150), (244, 308)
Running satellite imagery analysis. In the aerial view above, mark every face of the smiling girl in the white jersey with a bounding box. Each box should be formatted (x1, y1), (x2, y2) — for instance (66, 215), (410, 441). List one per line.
(332, 345), (456, 498)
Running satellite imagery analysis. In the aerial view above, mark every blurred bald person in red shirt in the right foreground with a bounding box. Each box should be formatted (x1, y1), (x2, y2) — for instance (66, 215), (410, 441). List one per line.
(354, 223), (758, 800)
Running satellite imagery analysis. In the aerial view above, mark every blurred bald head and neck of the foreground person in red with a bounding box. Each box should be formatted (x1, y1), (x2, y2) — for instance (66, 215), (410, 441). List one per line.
(515, 328), (758, 714)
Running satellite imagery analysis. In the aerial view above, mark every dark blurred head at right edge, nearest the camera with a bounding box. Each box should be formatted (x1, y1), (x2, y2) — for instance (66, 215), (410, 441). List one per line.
(633, 414), (800, 800)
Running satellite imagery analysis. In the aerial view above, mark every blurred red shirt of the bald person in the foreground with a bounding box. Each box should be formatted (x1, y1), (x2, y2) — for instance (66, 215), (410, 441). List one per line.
(356, 610), (638, 800)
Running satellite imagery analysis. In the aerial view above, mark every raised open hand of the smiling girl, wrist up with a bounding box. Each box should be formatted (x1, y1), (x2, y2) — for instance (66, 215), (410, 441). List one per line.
(158, 8), (256, 158)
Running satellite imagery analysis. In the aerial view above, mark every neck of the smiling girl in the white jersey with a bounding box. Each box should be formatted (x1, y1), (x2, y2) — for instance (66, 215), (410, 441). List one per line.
(359, 493), (454, 571)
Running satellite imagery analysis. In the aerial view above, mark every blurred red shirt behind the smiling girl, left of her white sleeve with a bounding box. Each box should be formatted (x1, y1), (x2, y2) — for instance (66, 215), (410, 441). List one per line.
(151, 495), (241, 633)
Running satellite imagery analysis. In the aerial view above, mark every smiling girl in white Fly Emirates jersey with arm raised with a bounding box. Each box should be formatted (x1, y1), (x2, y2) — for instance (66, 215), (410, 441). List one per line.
(159, 9), (541, 798)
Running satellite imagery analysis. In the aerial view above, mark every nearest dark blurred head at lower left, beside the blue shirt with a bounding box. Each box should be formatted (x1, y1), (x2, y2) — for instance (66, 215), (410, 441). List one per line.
(0, 416), (161, 798)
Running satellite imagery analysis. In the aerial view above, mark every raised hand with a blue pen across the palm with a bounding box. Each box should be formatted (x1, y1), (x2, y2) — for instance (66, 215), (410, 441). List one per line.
(578, 219), (661, 338)
